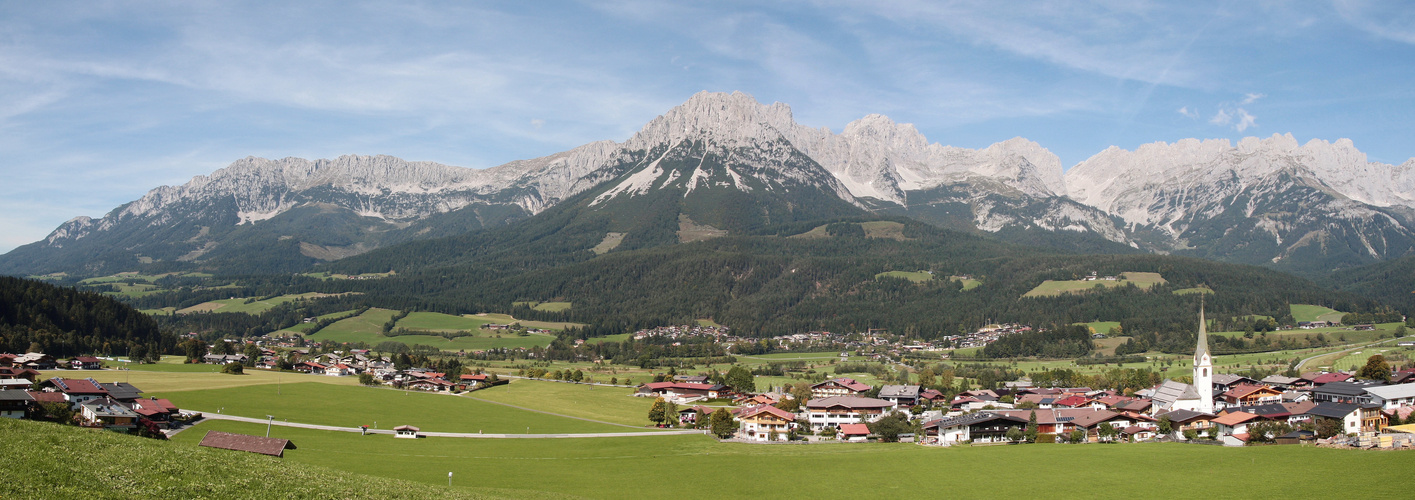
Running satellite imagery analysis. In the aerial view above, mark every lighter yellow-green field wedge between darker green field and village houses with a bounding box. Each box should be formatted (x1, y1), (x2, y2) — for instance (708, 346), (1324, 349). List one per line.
(467, 377), (654, 426)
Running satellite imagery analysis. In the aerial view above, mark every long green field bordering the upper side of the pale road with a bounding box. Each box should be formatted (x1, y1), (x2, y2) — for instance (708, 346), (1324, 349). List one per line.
(147, 375), (648, 433)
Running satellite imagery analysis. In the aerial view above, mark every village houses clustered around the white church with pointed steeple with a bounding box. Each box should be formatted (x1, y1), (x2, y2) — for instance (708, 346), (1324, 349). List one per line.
(638, 307), (1415, 448)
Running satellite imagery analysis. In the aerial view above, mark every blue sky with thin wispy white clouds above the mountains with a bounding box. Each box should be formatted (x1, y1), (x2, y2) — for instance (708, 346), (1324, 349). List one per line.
(0, 0), (1415, 252)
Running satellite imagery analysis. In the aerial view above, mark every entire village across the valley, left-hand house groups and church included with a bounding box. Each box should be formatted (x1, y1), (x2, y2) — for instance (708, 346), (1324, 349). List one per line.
(8, 305), (1415, 449)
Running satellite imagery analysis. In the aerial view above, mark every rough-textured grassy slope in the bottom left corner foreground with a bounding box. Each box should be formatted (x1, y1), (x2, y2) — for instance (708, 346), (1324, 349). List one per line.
(0, 418), (552, 500)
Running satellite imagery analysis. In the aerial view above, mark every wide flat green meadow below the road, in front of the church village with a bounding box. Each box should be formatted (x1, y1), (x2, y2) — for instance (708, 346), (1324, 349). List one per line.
(173, 421), (1415, 499)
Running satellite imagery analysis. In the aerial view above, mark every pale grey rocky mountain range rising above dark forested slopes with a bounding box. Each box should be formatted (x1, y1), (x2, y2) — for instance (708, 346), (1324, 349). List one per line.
(0, 92), (1415, 276)
